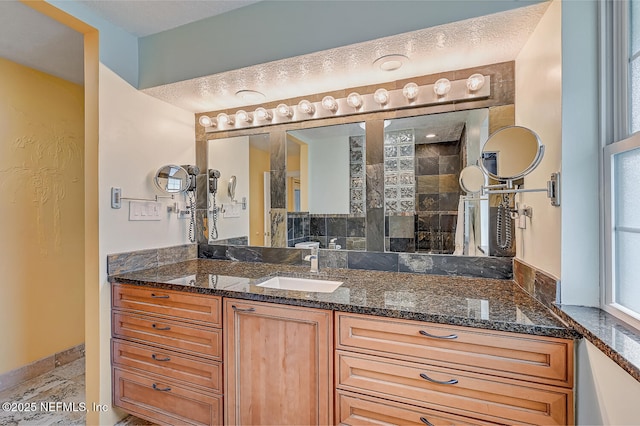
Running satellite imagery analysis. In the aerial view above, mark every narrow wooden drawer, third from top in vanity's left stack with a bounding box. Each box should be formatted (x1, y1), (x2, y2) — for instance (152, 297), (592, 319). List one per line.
(111, 339), (222, 393)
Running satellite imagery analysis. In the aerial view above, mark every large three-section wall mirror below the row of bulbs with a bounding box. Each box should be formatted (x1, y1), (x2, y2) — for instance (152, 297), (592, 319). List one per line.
(208, 108), (510, 256)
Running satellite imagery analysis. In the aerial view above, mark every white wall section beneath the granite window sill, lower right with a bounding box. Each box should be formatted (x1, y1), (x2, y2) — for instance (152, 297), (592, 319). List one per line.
(576, 339), (640, 425)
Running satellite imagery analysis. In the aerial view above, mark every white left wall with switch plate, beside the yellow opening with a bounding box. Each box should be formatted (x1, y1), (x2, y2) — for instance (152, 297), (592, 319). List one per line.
(96, 64), (195, 424)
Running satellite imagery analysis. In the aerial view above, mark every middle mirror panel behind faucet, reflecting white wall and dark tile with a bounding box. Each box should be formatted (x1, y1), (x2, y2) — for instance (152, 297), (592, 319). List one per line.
(287, 123), (366, 250)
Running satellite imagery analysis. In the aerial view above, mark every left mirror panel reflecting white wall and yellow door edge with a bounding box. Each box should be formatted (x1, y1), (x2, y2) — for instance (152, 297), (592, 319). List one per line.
(207, 134), (264, 246)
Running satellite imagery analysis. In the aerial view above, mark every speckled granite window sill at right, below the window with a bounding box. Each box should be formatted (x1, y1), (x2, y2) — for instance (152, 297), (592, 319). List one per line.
(552, 305), (640, 382)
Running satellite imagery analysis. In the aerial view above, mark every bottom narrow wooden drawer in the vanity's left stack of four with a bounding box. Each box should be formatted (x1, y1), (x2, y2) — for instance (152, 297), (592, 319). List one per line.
(113, 368), (223, 426)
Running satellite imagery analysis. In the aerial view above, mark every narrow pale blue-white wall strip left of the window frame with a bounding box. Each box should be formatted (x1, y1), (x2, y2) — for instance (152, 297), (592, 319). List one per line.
(562, 0), (601, 306)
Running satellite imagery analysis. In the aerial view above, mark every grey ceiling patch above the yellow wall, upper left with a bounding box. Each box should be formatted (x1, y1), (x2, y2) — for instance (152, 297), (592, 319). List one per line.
(0, 0), (84, 84)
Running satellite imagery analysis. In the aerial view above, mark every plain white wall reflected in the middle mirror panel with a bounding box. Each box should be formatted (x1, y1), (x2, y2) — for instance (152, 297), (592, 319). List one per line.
(308, 136), (350, 214)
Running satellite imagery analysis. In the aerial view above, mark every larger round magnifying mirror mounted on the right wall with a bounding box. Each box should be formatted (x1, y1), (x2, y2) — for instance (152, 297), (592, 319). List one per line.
(480, 126), (544, 181)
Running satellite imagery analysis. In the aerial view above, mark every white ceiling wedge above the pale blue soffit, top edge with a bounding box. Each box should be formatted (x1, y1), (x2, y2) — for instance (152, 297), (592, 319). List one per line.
(78, 0), (260, 37)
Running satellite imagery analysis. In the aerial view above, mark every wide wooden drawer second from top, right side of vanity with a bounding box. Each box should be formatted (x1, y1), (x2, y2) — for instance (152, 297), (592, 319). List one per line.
(336, 351), (573, 425)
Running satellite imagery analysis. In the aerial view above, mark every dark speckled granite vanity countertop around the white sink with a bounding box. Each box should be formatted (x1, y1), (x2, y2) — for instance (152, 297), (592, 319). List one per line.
(109, 259), (578, 338)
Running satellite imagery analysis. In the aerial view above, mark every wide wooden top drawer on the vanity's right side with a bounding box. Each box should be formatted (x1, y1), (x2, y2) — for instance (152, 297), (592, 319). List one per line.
(336, 314), (573, 388)
